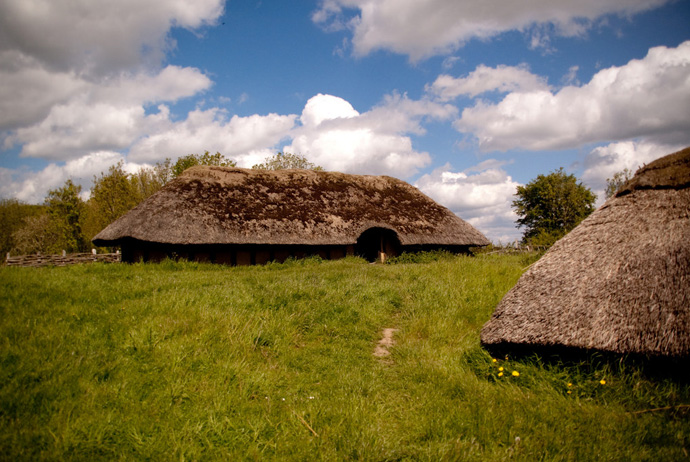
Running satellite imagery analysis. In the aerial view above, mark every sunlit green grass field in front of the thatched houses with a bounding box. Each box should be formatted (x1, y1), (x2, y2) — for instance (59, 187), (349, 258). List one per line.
(0, 255), (690, 461)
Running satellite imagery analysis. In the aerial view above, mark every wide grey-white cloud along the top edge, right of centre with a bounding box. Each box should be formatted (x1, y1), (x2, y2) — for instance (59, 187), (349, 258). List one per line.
(312, 0), (669, 61)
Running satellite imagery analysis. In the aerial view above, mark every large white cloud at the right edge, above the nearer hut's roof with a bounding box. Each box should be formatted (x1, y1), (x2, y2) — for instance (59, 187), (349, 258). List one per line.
(455, 41), (690, 151)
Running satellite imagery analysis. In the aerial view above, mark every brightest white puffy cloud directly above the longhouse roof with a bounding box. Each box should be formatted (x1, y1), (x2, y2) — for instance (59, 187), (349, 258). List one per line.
(284, 94), (456, 177)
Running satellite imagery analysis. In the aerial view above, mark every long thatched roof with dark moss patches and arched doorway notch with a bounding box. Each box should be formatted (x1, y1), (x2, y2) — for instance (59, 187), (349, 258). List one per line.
(93, 166), (489, 246)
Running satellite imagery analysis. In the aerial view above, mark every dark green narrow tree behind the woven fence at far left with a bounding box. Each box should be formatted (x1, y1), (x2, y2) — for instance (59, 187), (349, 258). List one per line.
(45, 180), (89, 252)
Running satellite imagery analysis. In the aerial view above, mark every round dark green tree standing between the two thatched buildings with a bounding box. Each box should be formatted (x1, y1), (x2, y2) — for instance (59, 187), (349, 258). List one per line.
(513, 167), (597, 245)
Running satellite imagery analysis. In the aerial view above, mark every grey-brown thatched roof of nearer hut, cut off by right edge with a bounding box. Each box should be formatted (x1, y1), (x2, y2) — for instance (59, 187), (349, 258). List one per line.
(481, 148), (690, 358)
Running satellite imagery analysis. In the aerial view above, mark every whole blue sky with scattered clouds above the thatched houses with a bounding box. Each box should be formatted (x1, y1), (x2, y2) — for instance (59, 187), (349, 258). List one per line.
(0, 0), (690, 242)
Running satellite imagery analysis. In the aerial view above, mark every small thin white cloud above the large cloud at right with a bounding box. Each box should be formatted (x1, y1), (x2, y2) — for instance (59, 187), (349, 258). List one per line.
(426, 64), (549, 101)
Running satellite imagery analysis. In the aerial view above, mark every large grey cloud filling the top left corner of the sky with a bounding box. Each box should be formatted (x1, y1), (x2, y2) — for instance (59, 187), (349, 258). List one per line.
(0, 0), (224, 76)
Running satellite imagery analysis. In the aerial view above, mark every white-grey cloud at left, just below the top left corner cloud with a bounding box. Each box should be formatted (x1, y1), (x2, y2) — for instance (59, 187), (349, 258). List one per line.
(0, 66), (211, 160)
